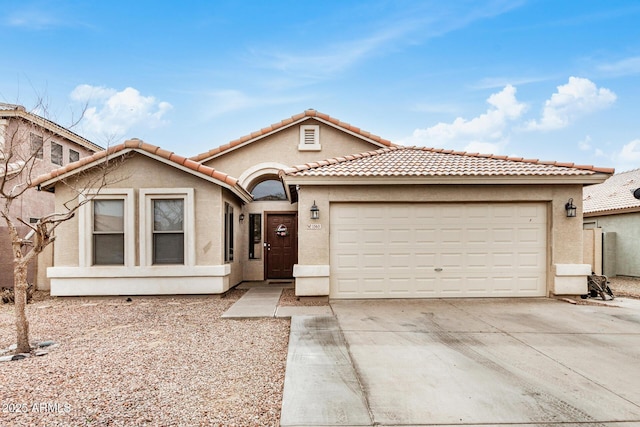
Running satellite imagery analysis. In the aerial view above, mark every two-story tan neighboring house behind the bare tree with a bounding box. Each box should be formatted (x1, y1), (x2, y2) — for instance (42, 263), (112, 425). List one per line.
(0, 103), (102, 288)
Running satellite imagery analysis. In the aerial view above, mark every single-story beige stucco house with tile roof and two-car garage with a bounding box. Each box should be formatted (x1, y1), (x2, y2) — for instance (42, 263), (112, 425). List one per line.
(34, 110), (613, 298)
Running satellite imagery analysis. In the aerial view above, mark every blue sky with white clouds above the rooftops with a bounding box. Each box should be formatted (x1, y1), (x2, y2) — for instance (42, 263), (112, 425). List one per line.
(0, 0), (640, 172)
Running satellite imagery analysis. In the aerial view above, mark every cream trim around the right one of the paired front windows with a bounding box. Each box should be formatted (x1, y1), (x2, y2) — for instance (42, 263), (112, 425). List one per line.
(139, 188), (196, 268)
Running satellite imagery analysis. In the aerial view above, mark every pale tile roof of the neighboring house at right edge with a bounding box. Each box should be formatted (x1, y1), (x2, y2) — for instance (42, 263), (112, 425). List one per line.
(582, 169), (640, 216)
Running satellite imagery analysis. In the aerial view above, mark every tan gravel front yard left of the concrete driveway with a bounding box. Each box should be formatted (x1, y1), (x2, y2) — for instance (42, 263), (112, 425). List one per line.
(0, 290), (289, 426)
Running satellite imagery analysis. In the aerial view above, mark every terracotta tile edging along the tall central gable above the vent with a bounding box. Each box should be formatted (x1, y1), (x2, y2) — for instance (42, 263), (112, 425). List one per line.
(191, 109), (394, 162)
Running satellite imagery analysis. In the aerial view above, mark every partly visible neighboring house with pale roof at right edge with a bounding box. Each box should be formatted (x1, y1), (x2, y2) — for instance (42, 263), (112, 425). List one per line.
(583, 169), (640, 277)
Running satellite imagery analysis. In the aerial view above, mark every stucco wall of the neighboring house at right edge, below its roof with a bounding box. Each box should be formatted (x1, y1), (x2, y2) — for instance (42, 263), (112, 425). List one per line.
(588, 212), (640, 277)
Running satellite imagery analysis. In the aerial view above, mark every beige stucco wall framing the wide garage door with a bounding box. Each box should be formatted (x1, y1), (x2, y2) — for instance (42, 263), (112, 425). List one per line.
(298, 185), (586, 294)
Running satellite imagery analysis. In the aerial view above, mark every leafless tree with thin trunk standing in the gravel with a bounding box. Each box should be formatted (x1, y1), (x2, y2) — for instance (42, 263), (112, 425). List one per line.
(0, 106), (114, 353)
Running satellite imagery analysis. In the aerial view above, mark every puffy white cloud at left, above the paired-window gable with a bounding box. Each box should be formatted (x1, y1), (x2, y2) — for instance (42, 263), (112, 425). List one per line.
(70, 84), (173, 138)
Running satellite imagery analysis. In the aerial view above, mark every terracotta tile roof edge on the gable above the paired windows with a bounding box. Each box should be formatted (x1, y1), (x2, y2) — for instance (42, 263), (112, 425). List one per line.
(31, 139), (248, 201)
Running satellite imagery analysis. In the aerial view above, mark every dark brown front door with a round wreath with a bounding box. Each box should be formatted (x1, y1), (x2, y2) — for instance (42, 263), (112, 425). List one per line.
(264, 213), (298, 279)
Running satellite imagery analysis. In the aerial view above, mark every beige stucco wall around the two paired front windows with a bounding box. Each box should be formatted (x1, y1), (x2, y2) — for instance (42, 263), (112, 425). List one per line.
(48, 154), (245, 295)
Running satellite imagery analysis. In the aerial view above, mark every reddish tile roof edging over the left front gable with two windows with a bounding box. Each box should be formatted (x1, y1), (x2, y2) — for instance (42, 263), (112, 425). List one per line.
(31, 139), (252, 202)
